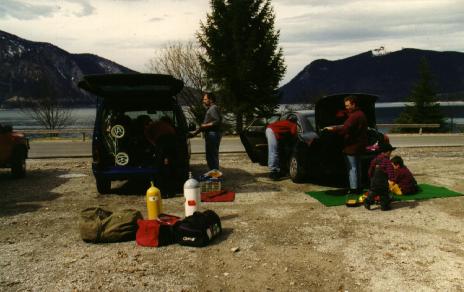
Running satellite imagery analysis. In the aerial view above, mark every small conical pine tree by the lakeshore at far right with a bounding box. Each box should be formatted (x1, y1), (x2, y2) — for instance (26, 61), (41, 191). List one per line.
(396, 58), (444, 132)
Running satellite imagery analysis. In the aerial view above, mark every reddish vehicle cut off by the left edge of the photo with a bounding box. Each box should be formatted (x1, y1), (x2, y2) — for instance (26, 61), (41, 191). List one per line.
(0, 124), (29, 178)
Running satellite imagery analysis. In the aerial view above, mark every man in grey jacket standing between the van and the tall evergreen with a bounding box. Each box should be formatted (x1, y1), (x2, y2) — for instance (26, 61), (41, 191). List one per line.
(191, 92), (222, 170)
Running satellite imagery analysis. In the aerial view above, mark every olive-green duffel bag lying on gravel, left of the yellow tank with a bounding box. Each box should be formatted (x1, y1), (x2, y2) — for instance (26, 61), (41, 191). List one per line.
(79, 207), (143, 243)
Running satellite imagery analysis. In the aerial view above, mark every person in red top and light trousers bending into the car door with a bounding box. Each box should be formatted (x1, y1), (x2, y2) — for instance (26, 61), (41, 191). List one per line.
(266, 117), (297, 180)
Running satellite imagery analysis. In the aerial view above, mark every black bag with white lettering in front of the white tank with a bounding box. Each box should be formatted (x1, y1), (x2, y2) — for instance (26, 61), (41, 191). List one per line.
(174, 210), (222, 247)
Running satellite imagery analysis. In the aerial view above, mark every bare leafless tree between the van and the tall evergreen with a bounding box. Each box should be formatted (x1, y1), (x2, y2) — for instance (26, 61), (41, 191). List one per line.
(147, 41), (208, 124)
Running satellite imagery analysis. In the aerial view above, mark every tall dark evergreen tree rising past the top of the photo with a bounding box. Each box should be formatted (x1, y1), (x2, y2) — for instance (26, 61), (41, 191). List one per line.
(197, 0), (286, 132)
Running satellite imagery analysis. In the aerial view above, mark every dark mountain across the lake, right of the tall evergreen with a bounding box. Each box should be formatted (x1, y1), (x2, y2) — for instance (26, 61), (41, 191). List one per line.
(280, 49), (464, 103)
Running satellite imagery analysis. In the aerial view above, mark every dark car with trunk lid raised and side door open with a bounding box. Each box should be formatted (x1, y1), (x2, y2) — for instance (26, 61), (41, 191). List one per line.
(240, 93), (388, 183)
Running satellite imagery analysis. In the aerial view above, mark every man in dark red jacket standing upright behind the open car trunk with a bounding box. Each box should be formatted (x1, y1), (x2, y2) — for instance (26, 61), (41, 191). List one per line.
(325, 96), (368, 194)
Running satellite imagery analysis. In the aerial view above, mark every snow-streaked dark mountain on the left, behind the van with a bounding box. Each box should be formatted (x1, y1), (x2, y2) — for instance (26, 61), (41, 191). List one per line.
(0, 31), (134, 107)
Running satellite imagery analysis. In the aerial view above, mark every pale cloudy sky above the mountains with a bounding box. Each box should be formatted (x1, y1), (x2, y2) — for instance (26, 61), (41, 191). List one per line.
(0, 0), (464, 85)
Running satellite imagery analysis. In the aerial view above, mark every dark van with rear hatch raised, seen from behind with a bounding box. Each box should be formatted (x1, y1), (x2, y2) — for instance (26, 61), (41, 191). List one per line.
(79, 74), (191, 196)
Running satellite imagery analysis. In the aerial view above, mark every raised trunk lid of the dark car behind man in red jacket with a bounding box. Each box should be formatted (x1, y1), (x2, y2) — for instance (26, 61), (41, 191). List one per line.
(315, 93), (377, 132)
